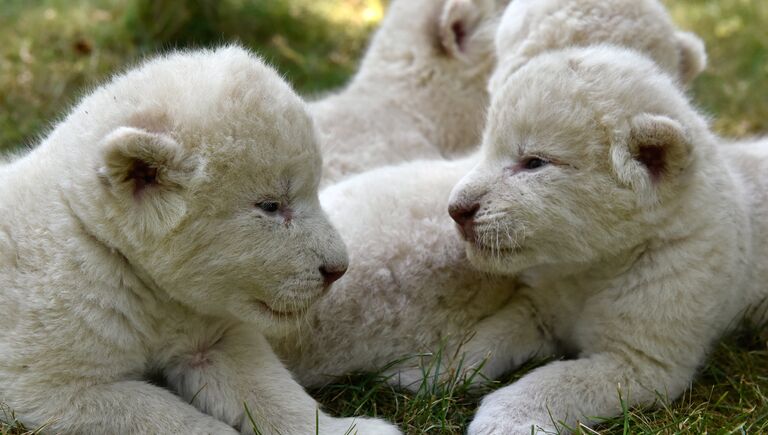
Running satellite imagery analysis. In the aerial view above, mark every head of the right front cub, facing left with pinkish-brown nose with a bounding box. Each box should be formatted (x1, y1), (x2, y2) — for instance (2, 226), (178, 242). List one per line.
(449, 46), (711, 274)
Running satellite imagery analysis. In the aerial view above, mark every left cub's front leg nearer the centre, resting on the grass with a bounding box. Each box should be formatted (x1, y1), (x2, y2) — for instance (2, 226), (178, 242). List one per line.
(166, 326), (400, 435)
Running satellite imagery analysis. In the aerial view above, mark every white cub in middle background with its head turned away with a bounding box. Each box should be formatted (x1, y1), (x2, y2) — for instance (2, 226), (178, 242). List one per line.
(310, 0), (509, 184)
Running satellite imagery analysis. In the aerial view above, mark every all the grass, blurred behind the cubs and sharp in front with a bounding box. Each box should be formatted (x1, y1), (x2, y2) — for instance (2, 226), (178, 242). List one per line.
(0, 0), (768, 435)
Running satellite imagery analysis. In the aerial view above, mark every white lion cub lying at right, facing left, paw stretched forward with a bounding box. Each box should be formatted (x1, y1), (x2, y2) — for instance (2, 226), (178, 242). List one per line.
(450, 46), (768, 435)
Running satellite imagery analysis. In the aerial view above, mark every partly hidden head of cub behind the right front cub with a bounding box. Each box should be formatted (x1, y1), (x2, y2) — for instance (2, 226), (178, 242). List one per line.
(489, 0), (707, 90)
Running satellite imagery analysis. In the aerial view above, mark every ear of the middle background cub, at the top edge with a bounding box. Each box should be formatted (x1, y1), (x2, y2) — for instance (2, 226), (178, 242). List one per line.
(438, 0), (495, 59)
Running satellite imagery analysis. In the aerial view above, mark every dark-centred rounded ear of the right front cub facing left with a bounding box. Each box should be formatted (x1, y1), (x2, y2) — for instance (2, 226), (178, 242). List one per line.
(629, 113), (693, 183)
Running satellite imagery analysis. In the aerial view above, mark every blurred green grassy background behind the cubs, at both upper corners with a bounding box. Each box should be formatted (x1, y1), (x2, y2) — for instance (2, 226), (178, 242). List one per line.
(0, 0), (768, 155)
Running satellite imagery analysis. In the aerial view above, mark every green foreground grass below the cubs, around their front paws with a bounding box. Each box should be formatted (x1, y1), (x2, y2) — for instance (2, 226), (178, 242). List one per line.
(314, 327), (768, 434)
